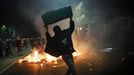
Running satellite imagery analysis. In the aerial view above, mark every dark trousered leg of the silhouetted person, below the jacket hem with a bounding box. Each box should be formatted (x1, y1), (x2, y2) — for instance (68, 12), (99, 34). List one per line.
(62, 54), (77, 75)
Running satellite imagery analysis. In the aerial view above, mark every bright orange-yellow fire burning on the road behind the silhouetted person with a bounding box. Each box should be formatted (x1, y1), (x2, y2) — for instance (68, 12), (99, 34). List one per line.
(18, 47), (80, 64)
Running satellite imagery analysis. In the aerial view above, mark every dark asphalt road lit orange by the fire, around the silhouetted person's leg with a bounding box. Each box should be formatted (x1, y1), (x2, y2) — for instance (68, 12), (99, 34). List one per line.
(1, 51), (130, 75)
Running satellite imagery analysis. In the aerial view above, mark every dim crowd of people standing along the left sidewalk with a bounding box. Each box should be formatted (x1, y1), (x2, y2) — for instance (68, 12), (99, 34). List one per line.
(0, 37), (37, 57)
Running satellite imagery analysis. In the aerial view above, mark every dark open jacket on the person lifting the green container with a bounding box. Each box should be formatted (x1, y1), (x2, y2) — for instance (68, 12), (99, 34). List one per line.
(45, 21), (75, 56)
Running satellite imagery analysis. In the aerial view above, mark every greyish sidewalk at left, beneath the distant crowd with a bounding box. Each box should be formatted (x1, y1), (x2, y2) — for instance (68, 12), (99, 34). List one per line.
(0, 48), (31, 74)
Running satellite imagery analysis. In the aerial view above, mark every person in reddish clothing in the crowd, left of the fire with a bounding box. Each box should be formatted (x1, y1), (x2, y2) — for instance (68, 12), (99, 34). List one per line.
(16, 37), (24, 56)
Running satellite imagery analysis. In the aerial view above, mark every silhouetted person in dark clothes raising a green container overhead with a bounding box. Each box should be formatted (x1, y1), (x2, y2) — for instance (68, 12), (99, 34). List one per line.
(45, 17), (77, 75)
